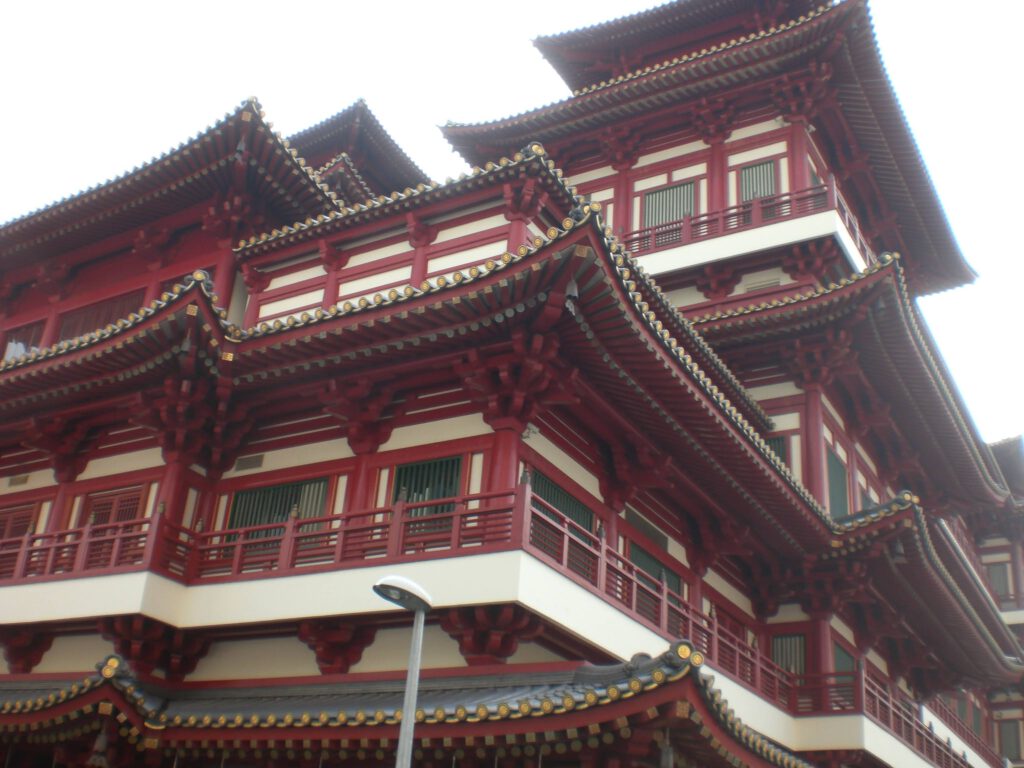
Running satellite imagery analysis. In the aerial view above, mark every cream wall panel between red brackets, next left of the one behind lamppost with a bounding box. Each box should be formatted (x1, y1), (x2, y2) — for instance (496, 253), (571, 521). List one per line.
(185, 637), (321, 682)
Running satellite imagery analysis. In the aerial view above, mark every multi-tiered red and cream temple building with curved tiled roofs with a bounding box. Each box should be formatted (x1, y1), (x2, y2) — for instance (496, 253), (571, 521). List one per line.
(0, 0), (1024, 768)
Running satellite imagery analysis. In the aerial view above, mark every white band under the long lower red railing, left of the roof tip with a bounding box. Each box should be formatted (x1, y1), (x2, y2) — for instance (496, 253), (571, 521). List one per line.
(0, 552), (667, 663)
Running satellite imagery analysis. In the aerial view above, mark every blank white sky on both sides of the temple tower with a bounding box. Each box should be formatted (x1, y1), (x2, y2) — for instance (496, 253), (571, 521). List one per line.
(0, 0), (1024, 440)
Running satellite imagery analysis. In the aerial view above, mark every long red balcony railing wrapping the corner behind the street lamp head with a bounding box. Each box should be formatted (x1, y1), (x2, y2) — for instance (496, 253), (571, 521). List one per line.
(0, 482), (1001, 768)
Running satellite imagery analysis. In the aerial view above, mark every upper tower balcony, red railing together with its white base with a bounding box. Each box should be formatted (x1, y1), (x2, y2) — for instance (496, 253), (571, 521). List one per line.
(623, 177), (877, 274)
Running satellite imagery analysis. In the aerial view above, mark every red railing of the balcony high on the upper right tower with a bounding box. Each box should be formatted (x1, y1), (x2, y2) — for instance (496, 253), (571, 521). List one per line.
(623, 178), (876, 262)
